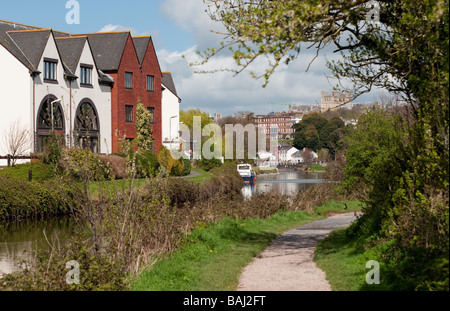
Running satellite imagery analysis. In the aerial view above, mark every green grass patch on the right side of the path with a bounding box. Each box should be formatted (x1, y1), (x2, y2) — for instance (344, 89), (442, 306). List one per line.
(314, 228), (395, 291)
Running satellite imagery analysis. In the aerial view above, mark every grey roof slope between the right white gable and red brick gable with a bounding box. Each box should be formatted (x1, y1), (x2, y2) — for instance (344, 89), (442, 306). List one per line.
(73, 31), (130, 71)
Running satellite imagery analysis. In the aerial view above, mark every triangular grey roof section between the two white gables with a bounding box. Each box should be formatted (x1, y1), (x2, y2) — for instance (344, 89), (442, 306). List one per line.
(56, 37), (87, 75)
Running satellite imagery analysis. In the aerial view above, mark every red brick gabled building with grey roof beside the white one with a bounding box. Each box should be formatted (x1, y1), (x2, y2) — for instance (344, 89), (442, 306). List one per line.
(74, 32), (162, 153)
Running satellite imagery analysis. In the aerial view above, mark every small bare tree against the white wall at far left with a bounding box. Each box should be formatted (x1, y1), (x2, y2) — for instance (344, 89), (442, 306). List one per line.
(3, 120), (31, 166)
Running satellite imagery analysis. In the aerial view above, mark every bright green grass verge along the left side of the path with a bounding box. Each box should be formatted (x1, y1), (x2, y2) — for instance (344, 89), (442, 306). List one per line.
(132, 203), (362, 291)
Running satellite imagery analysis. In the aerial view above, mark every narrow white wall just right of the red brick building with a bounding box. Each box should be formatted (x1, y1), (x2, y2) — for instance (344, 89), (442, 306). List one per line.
(162, 88), (180, 147)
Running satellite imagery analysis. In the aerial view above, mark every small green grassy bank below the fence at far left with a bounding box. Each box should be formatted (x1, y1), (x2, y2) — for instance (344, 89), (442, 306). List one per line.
(0, 162), (55, 181)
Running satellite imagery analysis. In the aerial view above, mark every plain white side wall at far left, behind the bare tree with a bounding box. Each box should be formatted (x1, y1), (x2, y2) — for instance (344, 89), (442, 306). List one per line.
(0, 45), (33, 166)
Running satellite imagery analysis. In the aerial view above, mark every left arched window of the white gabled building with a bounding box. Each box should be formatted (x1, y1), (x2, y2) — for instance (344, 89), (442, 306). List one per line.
(37, 95), (65, 153)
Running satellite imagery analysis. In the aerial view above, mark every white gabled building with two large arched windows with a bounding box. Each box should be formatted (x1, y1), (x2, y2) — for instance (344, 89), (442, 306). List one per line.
(0, 20), (114, 166)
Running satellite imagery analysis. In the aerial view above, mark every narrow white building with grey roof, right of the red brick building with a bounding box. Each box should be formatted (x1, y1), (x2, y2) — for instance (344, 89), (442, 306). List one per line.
(162, 72), (181, 150)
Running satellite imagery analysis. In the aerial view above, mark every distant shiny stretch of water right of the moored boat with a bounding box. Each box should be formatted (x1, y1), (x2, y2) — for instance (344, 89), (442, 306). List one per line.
(242, 171), (323, 199)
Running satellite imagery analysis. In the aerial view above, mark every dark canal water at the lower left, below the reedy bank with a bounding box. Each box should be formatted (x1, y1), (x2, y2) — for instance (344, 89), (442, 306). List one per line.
(0, 218), (76, 277)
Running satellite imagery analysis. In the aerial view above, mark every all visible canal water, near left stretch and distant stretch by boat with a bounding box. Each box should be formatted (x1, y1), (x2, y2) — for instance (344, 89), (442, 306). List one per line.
(0, 171), (322, 277)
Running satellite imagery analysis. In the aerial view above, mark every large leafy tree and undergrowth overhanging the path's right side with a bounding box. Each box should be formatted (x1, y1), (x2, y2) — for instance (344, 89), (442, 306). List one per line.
(201, 0), (449, 290)
